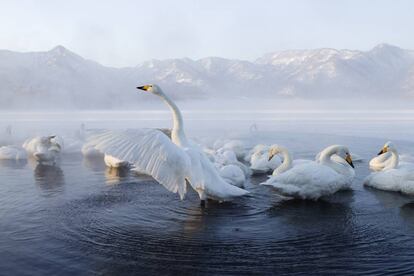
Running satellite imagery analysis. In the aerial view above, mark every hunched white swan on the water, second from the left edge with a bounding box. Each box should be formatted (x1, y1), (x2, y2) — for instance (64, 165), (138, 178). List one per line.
(23, 135), (62, 164)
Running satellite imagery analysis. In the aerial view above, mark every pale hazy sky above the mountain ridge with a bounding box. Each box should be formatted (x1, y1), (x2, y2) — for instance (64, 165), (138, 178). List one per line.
(0, 0), (414, 67)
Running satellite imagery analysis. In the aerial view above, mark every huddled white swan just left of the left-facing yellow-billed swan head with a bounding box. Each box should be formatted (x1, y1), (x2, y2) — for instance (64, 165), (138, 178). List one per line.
(245, 144), (282, 175)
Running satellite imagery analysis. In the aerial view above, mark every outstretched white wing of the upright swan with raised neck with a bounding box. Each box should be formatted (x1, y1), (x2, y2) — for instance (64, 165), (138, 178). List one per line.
(87, 129), (190, 199)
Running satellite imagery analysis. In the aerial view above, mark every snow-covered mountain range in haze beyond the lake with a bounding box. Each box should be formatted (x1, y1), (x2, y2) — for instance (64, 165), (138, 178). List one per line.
(0, 44), (414, 109)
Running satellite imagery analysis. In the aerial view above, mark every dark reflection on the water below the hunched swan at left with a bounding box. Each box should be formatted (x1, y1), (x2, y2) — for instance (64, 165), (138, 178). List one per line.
(34, 164), (65, 192)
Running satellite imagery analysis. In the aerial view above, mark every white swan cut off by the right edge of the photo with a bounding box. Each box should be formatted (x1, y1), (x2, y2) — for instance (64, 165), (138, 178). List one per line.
(364, 142), (414, 194)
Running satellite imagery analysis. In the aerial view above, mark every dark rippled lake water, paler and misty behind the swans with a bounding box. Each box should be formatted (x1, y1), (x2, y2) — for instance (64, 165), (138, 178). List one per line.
(0, 111), (414, 275)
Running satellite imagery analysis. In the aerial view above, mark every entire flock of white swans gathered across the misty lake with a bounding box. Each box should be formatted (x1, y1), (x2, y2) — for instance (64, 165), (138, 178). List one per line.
(0, 85), (414, 203)
